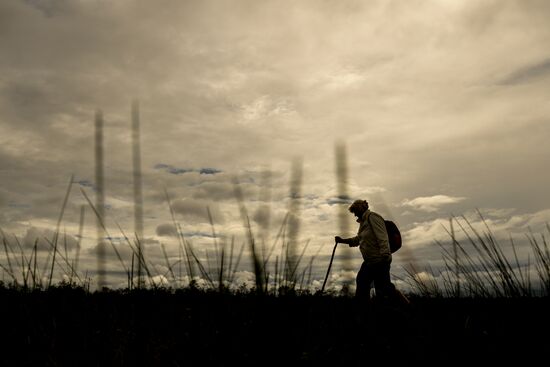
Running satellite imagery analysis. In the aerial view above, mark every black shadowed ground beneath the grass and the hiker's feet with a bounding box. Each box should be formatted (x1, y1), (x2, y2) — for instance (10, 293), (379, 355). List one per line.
(0, 288), (550, 366)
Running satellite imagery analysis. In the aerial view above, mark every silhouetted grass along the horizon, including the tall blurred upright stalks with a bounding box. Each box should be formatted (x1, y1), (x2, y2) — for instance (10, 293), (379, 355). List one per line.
(0, 107), (550, 297)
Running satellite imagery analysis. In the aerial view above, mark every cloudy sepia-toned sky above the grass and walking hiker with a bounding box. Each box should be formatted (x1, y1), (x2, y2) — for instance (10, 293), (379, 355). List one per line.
(0, 0), (550, 294)
